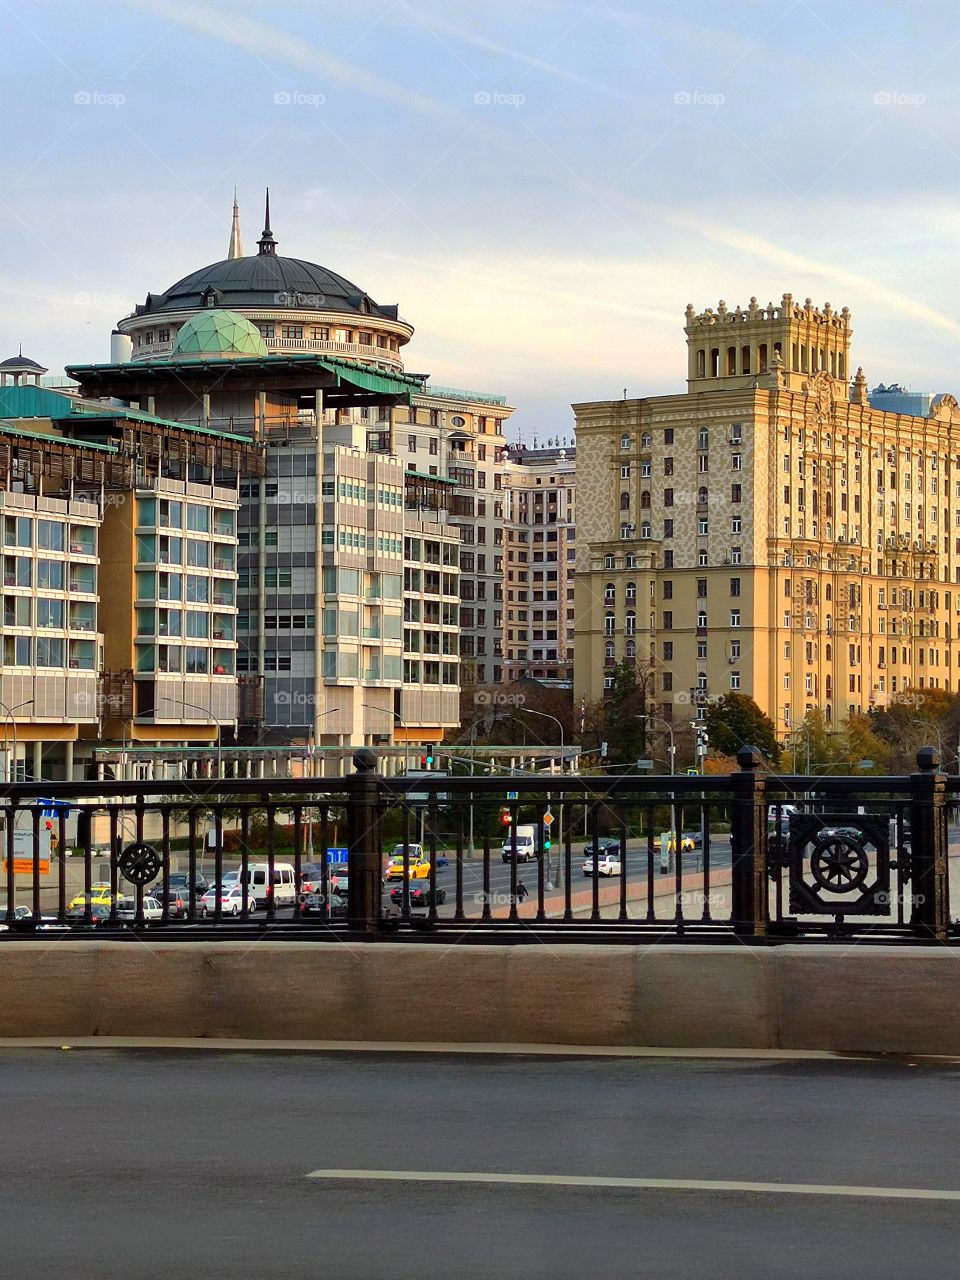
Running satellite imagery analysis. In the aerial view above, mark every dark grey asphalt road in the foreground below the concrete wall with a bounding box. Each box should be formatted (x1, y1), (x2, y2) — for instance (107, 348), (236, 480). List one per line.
(0, 1050), (960, 1280)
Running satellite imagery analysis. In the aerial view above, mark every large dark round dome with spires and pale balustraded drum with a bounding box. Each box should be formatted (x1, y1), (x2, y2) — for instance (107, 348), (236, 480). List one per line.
(118, 192), (413, 370)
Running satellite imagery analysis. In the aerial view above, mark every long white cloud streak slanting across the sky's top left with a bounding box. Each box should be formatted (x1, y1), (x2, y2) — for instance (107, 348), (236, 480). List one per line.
(119, 0), (454, 115)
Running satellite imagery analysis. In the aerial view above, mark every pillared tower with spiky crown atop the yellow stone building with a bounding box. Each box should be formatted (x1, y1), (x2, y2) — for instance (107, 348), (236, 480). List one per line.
(684, 293), (852, 398)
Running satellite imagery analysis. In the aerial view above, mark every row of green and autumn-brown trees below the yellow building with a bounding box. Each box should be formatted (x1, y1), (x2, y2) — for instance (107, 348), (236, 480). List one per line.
(457, 662), (960, 774)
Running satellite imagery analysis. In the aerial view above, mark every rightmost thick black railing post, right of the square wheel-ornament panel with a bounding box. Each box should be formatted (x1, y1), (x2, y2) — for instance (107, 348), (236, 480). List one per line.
(910, 746), (950, 941)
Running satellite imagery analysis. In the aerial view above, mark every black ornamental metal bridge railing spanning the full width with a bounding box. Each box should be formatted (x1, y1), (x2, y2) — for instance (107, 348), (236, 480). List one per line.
(0, 748), (960, 942)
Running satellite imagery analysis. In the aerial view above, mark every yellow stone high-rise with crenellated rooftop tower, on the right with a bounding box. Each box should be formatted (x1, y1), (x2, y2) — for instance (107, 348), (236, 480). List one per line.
(573, 293), (960, 739)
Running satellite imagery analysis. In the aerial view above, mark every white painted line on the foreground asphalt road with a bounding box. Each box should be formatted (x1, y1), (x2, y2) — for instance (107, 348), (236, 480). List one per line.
(306, 1169), (960, 1201)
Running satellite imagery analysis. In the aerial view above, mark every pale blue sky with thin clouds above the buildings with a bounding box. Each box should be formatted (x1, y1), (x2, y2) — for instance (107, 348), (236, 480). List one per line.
(0, 0), (960, 443)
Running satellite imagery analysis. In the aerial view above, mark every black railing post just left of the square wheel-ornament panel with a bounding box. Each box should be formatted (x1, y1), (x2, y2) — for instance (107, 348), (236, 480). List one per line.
(730, 746), (769, 937)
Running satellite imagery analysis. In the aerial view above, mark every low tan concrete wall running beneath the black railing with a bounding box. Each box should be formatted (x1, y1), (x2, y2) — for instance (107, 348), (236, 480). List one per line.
(0, 938), (960, 1055)
